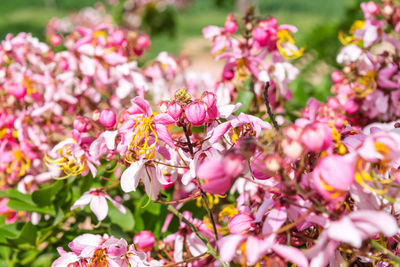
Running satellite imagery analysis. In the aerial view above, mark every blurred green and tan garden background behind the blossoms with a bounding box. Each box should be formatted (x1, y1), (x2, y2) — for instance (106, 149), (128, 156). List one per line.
(0, 0), (362, 108)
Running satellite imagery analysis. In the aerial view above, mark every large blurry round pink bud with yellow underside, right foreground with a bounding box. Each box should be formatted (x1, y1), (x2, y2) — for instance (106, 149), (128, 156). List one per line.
(312, 155), (354, 199)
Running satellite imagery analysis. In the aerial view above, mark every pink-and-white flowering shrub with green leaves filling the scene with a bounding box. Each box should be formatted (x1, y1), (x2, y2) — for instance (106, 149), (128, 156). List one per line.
(0, 1), (400, 267)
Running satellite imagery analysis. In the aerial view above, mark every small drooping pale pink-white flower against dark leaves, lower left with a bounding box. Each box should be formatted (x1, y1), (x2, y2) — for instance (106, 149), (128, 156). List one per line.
(71, 189), (126, 221)
